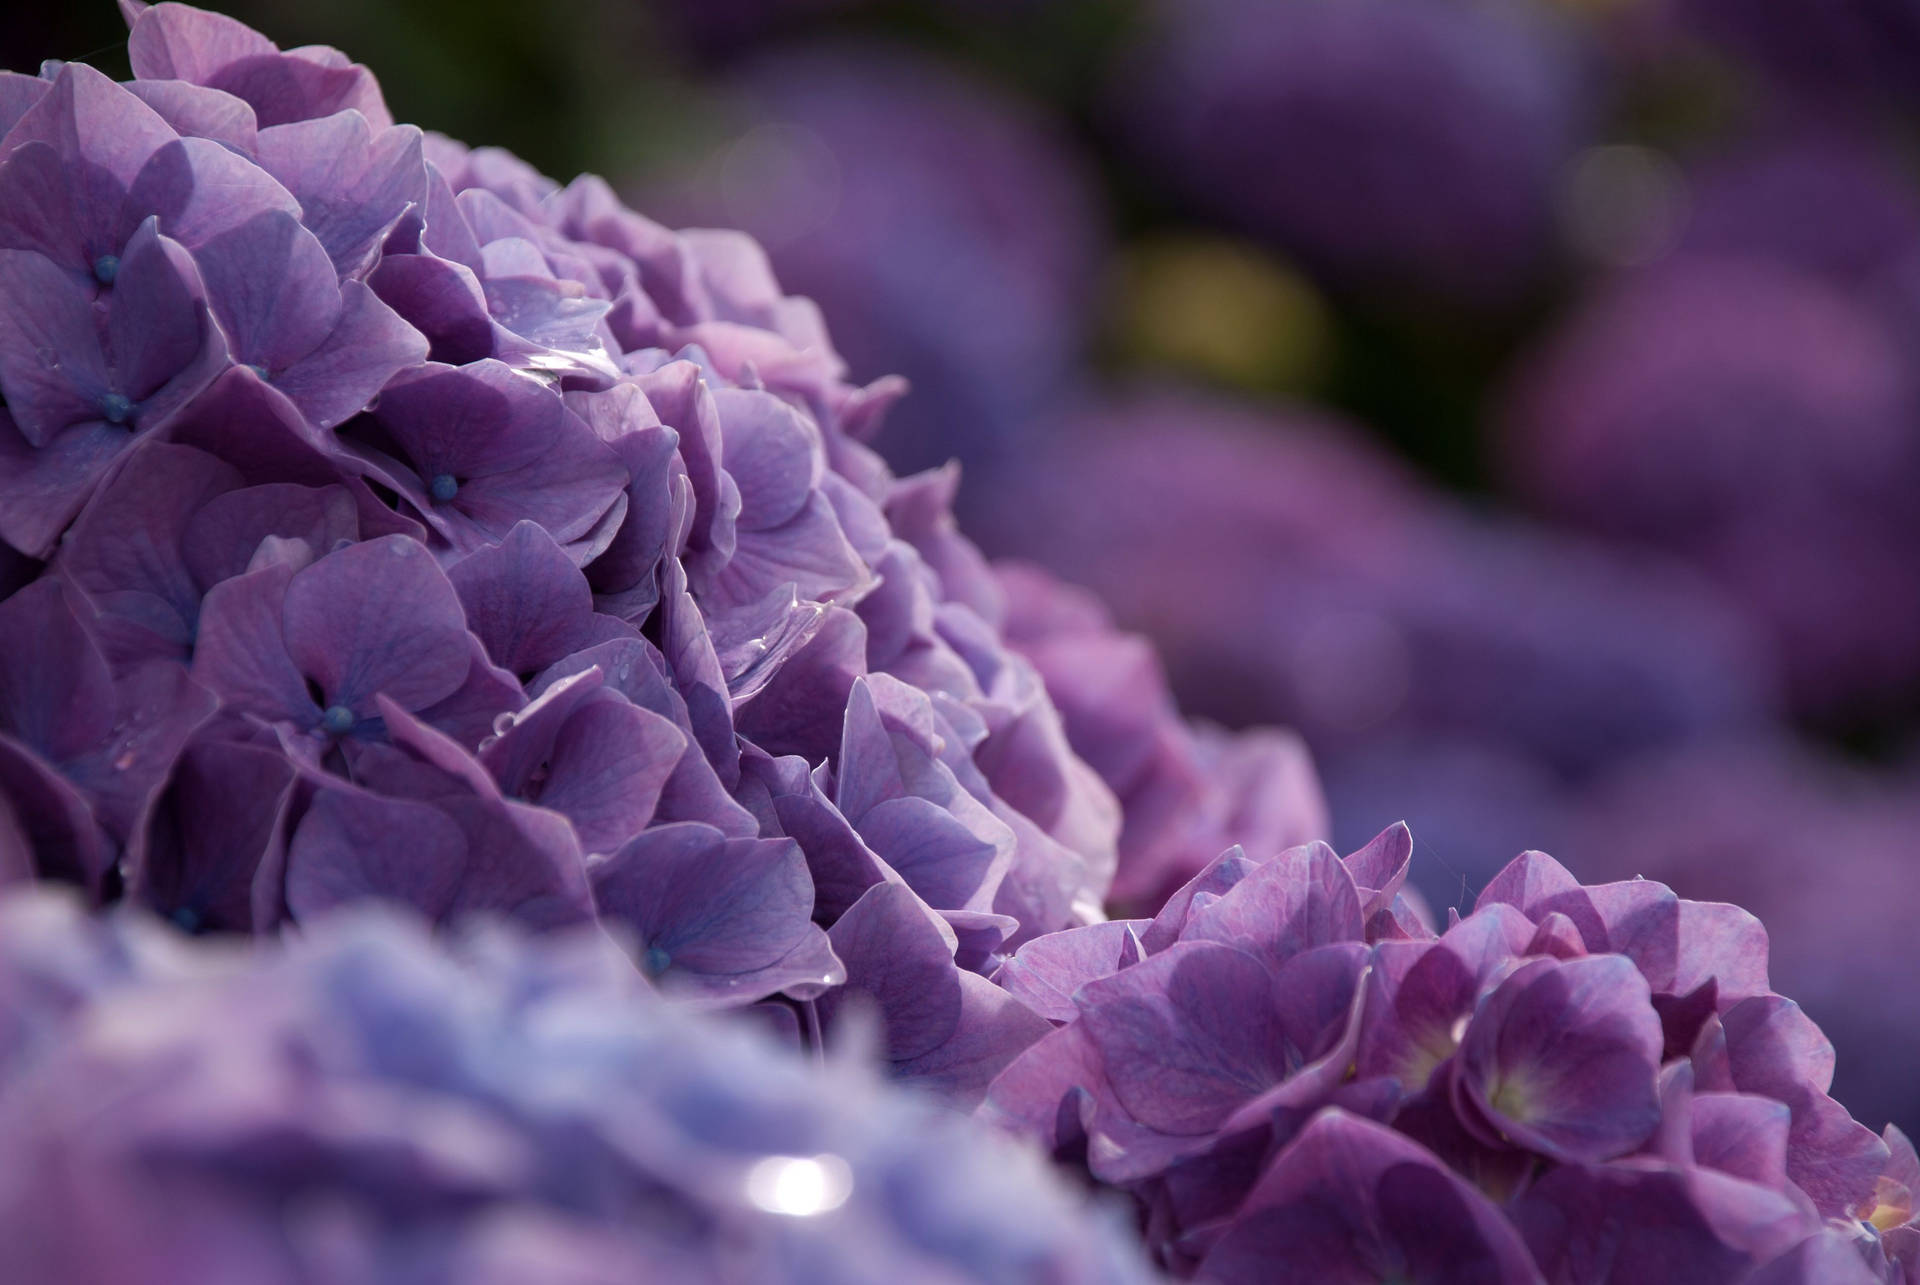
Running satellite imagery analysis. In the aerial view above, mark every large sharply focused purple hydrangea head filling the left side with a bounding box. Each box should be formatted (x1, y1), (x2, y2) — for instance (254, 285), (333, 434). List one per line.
(0, 4), (1323, 1099)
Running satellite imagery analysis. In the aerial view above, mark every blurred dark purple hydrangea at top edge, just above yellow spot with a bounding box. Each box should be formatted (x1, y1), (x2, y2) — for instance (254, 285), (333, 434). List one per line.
(1114, 0), (1588, 303)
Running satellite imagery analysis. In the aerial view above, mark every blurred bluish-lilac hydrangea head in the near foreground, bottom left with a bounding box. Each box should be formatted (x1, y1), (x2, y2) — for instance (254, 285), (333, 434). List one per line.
(0, 891), (1152, 1285)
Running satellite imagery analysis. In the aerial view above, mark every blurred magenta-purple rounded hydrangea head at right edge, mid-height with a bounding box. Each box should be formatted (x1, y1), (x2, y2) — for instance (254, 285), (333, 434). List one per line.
(1507, 249), (1920, 713)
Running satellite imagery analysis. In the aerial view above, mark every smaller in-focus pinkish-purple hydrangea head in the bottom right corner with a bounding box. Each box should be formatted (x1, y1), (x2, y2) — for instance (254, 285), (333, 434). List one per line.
(983, 826), (1920, 1285)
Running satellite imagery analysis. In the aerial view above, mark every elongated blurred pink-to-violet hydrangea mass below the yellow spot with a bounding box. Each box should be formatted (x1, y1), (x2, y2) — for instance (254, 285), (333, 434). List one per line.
(977, 390), (1774, 775)
